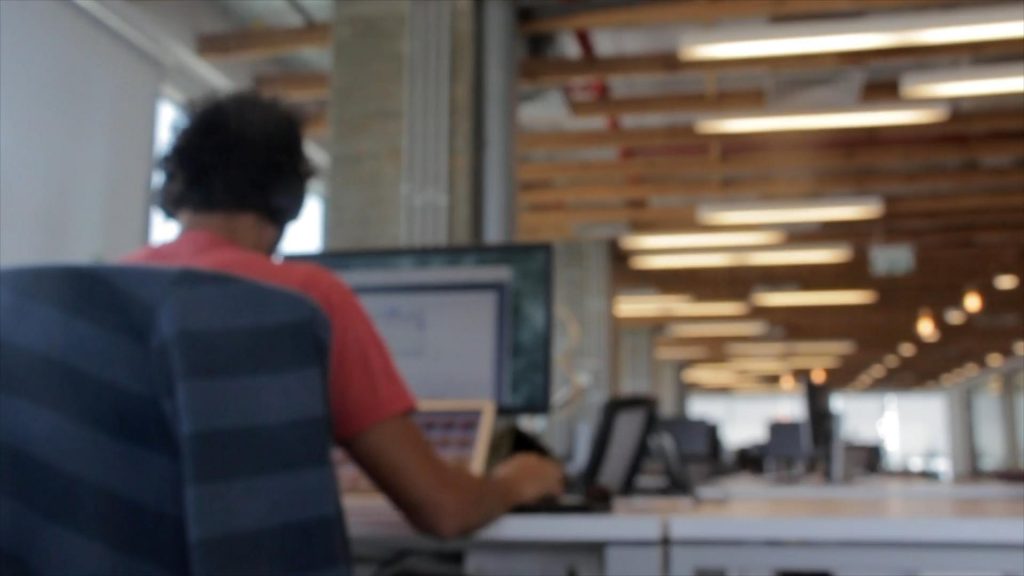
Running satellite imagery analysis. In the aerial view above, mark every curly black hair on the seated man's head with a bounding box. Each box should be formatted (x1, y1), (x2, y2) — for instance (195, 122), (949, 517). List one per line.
(160, 92), (312, 227)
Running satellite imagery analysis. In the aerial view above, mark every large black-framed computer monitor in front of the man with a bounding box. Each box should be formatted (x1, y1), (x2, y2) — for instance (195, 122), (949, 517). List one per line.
(297, 245), (552, 414)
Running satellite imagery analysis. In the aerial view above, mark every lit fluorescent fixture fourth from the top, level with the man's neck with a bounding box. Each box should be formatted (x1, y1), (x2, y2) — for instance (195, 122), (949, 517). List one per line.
(696, 196), (886, 225)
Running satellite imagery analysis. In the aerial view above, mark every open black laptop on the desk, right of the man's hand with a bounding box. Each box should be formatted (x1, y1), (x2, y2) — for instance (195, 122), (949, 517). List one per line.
(512, 398), (655, 513)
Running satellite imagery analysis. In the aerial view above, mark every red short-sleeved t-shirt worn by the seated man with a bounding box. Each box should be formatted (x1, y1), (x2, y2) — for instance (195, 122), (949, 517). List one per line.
(124, 231), (415, 443)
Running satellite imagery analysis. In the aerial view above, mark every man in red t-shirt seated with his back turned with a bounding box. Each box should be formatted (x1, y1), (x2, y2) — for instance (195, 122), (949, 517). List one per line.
(126, 94), (562, 537)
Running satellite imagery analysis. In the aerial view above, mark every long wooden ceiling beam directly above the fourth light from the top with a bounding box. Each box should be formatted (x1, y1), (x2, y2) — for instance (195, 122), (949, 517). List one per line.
(519, 168), (1024, 204)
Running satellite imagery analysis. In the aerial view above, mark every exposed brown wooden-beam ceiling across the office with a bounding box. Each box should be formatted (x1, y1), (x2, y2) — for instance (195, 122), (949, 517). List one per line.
(193, 0), (1024, 387)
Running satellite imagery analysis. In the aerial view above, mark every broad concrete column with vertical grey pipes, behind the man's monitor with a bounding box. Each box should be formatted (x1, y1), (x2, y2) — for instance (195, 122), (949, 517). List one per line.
(327, 0), (475, 249)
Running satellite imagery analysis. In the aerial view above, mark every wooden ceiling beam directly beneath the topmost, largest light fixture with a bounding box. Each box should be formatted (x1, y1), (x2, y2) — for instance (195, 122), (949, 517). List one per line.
(519, 39), (1021, 86)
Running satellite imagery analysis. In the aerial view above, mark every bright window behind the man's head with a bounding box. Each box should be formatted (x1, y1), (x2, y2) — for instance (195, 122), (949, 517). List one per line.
(148, 98), (325, 255)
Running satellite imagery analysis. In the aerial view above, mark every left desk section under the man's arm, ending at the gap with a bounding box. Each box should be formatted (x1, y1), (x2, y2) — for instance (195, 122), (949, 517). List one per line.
(344, 498), (665, 576)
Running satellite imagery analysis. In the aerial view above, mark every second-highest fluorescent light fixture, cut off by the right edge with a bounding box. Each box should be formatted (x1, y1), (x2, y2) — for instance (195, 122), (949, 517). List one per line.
(899, 61), (1024, 99)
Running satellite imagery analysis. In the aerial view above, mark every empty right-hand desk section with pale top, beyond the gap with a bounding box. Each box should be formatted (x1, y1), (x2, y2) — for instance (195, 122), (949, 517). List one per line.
(630, 498), (1024, 576)
